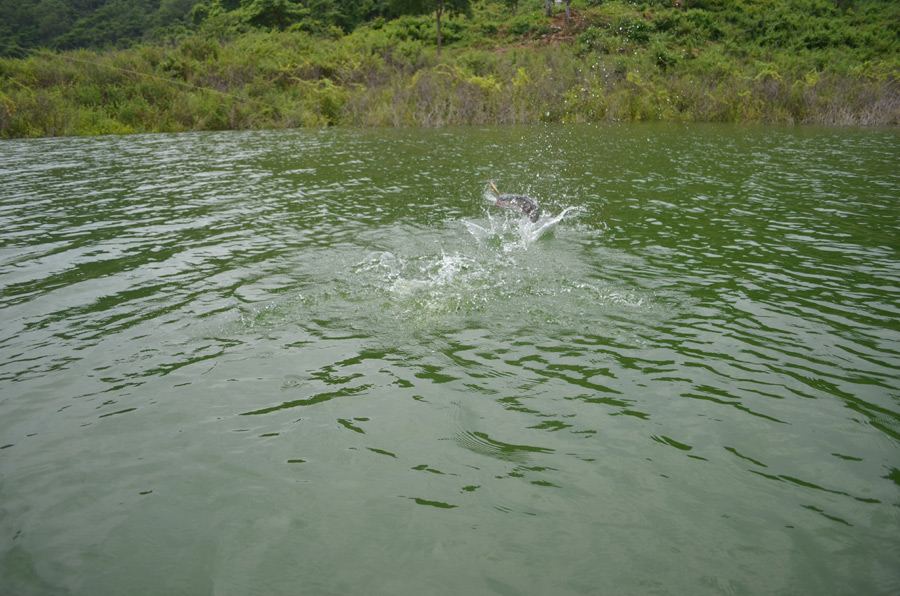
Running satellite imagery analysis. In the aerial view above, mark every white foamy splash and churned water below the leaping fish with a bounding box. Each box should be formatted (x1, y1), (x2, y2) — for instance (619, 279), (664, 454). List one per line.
(330, 199), (652, 337)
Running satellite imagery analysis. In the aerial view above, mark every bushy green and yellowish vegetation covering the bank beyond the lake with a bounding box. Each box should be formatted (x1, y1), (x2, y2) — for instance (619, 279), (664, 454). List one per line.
(0, 0), (900, 138)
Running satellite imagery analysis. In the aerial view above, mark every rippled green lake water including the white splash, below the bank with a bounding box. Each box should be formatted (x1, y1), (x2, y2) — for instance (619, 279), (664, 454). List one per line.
(0, 125), (900, 596)
